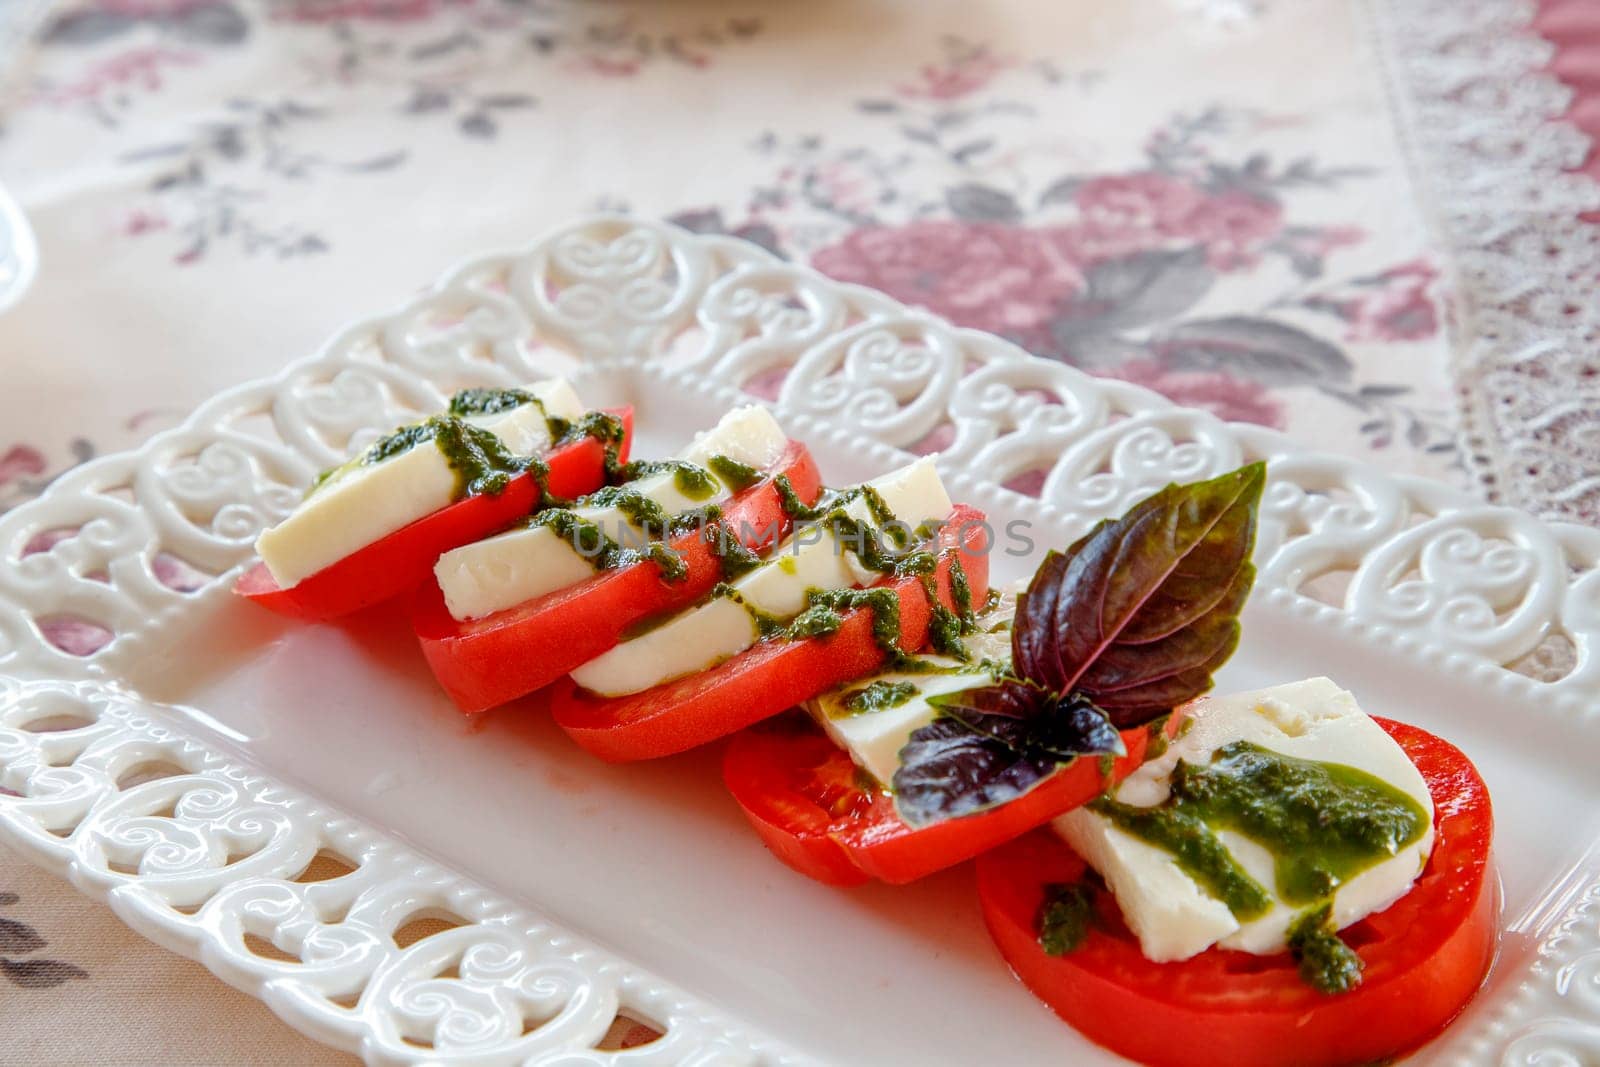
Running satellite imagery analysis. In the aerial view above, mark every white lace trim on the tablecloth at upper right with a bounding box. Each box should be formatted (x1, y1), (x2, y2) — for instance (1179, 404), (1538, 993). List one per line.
(1374, 0), (1600, 523)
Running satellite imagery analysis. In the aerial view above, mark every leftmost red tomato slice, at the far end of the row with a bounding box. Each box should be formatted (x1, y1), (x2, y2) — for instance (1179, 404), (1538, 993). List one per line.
(234, 408), (634, 622)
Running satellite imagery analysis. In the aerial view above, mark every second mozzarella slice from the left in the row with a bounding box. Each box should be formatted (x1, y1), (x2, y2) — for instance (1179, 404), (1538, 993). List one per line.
(434, 405), (787, 619)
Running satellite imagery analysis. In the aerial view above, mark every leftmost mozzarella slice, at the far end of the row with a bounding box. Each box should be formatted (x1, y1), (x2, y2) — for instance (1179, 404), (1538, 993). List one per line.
(256, 378), (584, 589)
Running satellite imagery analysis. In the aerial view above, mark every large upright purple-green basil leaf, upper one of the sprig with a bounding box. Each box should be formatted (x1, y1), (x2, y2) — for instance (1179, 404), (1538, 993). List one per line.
(1011, 462), (1266, 726)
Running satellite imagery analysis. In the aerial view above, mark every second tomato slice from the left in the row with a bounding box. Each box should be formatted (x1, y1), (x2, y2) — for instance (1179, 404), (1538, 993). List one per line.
(411, 442), (822, 713)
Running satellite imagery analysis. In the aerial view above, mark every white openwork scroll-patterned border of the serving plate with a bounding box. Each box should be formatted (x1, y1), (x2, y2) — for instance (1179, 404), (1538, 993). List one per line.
(0, 216), (1600, 1064)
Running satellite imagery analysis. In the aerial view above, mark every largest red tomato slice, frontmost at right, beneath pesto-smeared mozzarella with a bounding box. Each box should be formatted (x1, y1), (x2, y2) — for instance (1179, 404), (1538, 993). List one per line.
(978, 720), (1499, 1067)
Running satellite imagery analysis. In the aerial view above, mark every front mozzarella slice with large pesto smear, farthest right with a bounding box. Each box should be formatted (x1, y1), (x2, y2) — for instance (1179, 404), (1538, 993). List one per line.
(1053, 678), (1434, 961)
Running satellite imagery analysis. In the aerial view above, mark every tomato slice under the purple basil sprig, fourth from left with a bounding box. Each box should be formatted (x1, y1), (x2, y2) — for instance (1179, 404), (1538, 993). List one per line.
(722, 712), (1181, 886)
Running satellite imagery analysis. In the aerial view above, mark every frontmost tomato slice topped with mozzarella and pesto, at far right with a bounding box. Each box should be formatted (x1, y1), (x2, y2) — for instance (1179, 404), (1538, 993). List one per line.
(978, 678), (1499, 1067)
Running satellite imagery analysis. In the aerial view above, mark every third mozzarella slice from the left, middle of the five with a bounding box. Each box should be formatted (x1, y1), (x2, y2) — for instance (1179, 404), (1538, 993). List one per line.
(573, 459), (950, 696)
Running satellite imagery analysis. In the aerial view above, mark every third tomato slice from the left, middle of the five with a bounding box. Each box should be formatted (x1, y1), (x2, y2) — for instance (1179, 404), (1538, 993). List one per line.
(550, 504), (989, 761)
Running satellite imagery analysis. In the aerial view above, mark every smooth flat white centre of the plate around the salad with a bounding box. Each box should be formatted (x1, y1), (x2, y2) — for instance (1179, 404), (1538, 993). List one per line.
(112, 370), (1600, 1062)
